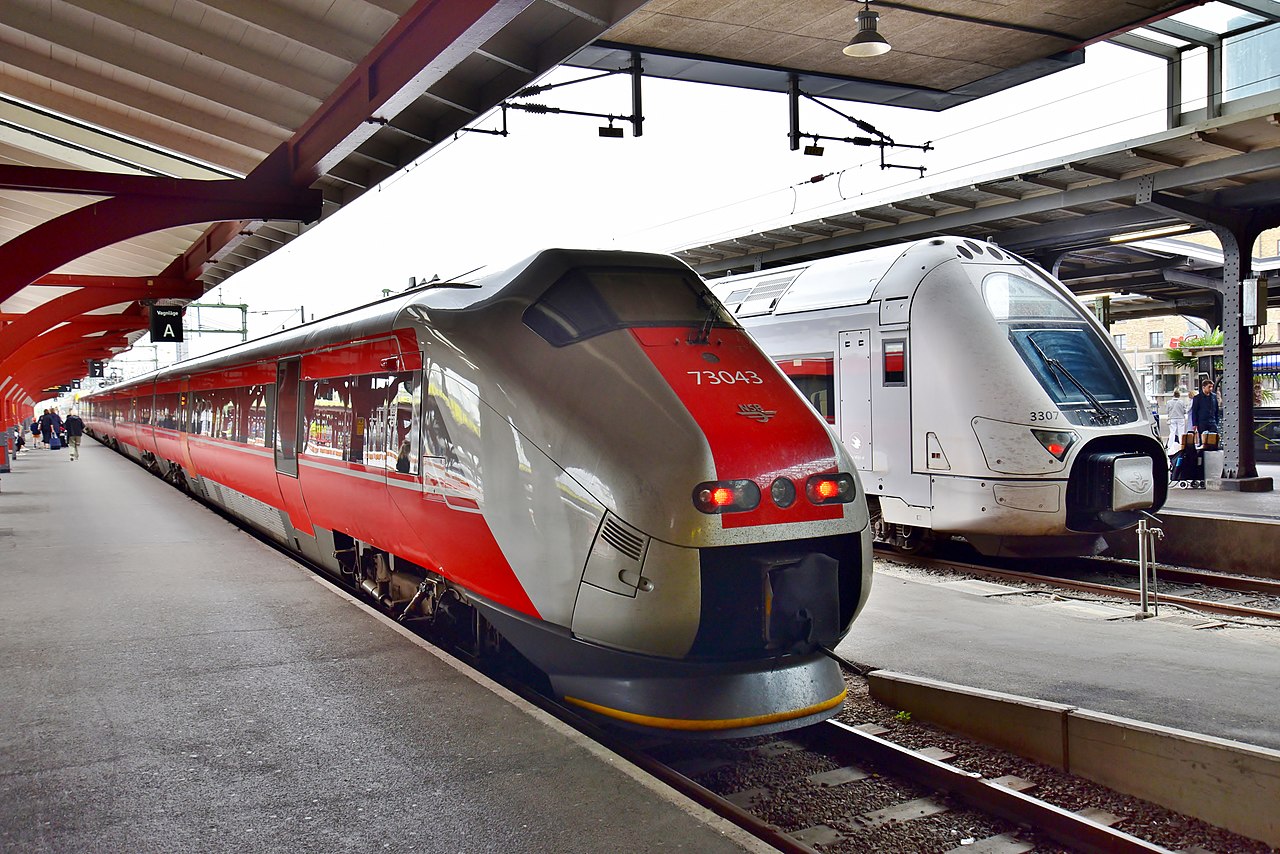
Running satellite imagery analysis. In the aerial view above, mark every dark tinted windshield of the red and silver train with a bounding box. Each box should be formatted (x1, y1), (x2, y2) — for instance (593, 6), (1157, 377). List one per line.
(524, 266), (737, 347)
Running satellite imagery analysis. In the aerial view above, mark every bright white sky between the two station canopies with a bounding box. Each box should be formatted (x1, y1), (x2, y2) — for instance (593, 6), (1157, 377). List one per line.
(116, 44), (1177, 375)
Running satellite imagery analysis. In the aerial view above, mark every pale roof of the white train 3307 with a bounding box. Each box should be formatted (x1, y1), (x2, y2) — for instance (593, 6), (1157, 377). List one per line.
(709, 237), (1021, 318)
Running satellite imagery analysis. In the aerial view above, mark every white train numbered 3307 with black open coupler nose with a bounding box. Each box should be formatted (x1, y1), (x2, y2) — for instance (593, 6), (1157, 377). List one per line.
(710, 237), (1169, 556)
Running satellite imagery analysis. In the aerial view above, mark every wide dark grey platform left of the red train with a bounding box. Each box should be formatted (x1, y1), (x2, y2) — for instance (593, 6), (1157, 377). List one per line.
(0, 442), (757, 853)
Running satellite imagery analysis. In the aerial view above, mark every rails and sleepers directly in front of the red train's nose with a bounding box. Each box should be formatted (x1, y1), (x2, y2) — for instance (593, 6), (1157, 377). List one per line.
(641, 721), (1167, 851)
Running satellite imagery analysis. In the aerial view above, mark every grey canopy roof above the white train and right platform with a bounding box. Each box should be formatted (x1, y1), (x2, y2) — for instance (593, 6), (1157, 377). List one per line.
(676, 104), (1280, 323)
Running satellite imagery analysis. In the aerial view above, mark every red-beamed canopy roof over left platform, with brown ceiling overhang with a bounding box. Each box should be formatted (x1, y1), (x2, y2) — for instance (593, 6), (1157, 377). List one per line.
(0, 0), (1259, 397)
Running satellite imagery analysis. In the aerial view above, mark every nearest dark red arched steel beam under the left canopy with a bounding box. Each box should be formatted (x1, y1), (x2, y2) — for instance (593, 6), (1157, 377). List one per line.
(0, 174), (321, 301)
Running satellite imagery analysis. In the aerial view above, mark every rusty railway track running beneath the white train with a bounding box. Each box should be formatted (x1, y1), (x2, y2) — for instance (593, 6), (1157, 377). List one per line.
(876, 547), (1280, 622)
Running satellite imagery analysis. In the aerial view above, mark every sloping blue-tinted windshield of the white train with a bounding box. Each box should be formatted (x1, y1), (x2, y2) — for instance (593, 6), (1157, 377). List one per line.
(982, 271), (1138, 425)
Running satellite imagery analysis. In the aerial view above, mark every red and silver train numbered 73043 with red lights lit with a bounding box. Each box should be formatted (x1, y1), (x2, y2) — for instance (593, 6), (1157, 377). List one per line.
(82, 250), (872, 735)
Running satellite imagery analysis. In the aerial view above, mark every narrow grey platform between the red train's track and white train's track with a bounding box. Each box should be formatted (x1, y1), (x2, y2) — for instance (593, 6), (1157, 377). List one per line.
(836, 562), (1280, 749)
